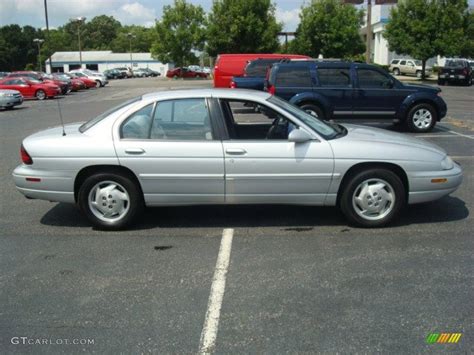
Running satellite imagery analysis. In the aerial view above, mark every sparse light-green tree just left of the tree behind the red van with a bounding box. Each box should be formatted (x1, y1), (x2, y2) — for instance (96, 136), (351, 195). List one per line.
(151, 0), (205, 66)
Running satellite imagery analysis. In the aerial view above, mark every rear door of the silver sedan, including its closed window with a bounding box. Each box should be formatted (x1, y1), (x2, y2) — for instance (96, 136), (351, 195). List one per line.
(115, 98), (224, 205)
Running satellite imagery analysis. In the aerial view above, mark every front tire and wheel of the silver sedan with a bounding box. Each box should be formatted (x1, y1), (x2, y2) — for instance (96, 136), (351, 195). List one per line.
(339, 168), (406, 228)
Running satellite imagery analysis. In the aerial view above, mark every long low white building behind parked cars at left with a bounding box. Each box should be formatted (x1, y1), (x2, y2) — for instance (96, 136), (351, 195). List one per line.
(45, 51), (173, 76)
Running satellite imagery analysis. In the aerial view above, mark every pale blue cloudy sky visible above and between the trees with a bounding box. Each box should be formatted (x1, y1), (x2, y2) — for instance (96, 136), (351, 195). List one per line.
(0, 0), (474, 31)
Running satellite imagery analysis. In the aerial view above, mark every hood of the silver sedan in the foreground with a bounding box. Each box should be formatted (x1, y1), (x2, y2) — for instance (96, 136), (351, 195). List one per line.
(344, 124), (446, 156)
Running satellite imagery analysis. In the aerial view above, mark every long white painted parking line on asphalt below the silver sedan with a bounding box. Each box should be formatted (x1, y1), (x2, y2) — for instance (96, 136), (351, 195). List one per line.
(199, 229), (234, 354)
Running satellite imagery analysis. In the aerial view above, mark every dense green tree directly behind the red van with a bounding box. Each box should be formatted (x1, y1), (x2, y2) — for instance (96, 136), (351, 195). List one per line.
(207, 0), (282, 56)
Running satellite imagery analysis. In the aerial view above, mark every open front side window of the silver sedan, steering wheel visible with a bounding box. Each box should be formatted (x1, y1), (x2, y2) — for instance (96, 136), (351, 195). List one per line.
(222, 100), (296, 140)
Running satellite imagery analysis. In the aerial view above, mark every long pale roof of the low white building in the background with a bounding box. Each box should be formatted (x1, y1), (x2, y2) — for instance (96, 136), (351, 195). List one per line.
(51, 51), (159, 64)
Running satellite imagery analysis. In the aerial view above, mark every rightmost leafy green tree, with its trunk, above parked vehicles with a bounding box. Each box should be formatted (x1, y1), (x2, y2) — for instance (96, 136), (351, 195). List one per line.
(383, 0), (472, 78)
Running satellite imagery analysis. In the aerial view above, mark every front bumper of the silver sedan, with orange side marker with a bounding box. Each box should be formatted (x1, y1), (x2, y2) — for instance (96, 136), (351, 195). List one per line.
(408, 163), (463, 204)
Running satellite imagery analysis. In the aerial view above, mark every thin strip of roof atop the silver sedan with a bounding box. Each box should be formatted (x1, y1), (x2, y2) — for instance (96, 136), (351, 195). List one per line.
(142, 89), (271, 100)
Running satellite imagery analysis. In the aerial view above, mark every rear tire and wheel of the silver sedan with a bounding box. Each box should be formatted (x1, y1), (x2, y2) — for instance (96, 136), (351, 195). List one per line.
(78, 173), (144, 230)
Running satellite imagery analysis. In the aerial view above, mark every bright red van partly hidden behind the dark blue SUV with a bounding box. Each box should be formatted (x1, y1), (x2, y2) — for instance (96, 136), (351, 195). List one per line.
(214, 53), (310, 88)
